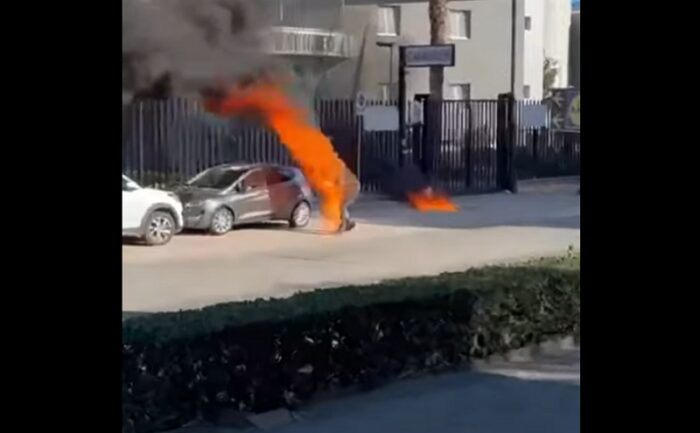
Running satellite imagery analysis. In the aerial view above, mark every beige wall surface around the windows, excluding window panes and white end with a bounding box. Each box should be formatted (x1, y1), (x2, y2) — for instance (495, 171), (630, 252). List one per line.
(321, 0), (524, 99)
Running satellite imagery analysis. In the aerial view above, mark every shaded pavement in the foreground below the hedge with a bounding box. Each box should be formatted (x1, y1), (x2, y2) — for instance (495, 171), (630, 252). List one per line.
(268, 348), (581, 433)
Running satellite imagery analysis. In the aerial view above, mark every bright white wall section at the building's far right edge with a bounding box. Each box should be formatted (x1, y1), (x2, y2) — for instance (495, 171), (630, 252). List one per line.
(544, 0), (571, 87)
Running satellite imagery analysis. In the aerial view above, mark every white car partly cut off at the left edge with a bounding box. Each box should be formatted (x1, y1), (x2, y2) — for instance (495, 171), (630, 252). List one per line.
(122, 175), (183, 245)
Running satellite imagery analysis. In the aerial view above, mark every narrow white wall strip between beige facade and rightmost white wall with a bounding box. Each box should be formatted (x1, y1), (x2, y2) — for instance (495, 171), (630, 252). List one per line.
(523, 0), (545, 99)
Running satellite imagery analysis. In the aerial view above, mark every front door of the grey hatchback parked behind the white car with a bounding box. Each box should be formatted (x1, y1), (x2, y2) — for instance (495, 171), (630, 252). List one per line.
(235, 168), (272, 222)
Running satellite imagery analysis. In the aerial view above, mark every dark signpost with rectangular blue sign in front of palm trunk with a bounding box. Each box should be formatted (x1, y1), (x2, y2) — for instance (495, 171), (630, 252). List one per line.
(399, 44), (455, 166)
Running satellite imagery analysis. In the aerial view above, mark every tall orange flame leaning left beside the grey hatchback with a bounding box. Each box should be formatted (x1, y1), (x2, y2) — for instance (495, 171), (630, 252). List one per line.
(205, 82), (357, 229)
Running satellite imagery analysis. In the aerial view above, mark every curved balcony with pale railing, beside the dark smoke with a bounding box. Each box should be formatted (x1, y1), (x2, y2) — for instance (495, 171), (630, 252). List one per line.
(263, 26), (354, 60)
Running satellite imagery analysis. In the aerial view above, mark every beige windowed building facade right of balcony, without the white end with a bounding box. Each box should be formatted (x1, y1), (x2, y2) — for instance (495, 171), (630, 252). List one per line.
(318, 0), (524, 99)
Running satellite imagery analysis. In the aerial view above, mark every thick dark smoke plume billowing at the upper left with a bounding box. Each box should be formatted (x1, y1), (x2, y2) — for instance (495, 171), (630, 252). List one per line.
(122, 0), (279, 99)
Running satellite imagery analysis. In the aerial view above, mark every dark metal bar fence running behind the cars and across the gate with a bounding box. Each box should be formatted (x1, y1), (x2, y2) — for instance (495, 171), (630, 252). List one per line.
(122, 99), (580, 193)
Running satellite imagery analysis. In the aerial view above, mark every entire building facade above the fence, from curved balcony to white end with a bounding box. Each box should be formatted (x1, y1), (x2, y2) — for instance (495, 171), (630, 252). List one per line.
(124, 0), (571, 100)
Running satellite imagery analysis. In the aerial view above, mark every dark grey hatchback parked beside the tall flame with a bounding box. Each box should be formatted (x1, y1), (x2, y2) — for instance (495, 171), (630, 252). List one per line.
(176, 163), (311, 235)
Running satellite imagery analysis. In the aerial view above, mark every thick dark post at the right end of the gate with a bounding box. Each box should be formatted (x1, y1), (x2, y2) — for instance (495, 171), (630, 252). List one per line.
(496, 93), (518, 193)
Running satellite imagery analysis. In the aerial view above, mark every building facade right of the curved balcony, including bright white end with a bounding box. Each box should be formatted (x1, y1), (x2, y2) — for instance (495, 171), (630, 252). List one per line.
(318, 0), (571, 99)
